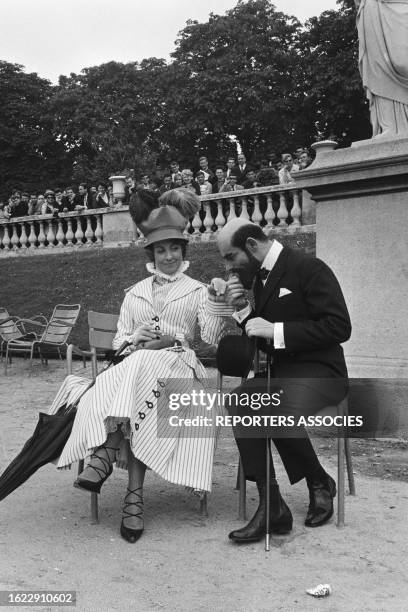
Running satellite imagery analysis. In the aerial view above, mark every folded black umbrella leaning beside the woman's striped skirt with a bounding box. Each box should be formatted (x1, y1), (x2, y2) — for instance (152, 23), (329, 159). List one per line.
(0, 343), (129, 501)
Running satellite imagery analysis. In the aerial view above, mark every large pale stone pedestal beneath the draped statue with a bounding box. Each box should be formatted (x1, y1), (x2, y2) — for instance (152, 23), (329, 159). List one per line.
(297, 139), (408, 436)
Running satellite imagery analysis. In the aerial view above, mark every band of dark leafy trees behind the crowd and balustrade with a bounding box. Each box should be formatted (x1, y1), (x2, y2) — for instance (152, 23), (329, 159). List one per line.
(0, 0), (371, 195)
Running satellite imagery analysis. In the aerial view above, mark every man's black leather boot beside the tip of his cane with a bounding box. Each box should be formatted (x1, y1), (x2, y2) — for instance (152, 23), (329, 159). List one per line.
(228, 480), (293, 544)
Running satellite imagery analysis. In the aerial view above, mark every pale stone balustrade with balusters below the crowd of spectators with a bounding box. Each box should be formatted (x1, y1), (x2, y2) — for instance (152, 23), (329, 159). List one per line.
(0, 184), (315, 257)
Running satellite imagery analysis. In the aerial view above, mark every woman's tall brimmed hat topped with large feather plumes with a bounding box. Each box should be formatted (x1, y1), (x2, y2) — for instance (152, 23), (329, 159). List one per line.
(129, 189), (200, 247)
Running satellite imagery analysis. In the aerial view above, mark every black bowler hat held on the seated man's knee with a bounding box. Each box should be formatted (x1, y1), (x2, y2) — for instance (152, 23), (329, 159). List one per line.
(216, 335), (255, 378)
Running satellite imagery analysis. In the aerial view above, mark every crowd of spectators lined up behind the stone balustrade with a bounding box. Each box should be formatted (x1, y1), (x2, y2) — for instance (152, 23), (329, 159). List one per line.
(0, 147), (312, 219)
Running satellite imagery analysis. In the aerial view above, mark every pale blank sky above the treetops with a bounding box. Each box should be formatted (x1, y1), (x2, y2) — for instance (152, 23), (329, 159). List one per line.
(0, 0), (337, 83)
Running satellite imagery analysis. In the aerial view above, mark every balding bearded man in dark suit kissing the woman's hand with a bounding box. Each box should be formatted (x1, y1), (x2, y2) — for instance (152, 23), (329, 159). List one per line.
(218, 218), (351, 542)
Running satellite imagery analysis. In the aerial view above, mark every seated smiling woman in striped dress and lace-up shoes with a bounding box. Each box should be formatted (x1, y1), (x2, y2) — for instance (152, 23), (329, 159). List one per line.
(51, 193), (230, 542)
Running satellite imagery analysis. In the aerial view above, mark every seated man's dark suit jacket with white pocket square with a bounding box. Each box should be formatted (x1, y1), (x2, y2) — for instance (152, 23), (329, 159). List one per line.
(243, 247), (351, 379)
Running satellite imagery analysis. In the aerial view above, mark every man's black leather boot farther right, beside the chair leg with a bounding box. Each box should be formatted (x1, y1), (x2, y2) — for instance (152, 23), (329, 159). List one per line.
(305, 470), (336, 527)
